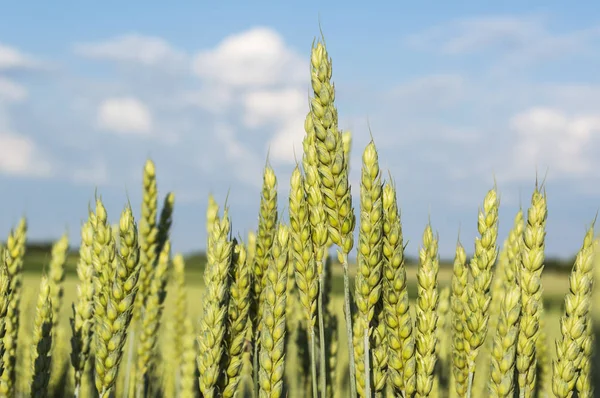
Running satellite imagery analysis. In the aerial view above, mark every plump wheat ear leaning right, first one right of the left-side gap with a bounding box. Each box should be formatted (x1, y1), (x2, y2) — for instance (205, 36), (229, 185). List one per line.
(198, 208), (233, 398)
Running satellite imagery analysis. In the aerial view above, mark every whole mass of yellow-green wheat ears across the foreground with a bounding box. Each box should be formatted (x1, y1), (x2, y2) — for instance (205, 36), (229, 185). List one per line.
(0, 34), (597, 398)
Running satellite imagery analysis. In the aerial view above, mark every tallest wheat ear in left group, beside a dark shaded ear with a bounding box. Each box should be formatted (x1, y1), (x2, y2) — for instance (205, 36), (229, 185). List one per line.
(133, 159), (158, 321)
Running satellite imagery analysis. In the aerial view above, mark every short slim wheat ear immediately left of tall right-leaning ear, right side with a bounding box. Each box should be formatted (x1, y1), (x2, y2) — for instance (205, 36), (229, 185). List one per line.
(450, 242), (469, 397)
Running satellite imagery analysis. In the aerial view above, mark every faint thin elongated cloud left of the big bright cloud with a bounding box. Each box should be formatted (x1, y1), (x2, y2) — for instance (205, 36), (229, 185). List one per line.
(74, 34), (187, 66)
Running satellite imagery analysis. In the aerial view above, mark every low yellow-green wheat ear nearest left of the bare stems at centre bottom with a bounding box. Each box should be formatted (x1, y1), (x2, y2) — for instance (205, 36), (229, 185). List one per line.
(259, 224), (289, 398)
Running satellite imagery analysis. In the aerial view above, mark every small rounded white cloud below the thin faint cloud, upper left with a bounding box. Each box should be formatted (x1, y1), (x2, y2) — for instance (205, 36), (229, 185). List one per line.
(97, 97), (152, 134)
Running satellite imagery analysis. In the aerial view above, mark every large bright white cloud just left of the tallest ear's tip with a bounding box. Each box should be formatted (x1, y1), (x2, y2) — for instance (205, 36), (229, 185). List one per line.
(193, 27), (308, 87)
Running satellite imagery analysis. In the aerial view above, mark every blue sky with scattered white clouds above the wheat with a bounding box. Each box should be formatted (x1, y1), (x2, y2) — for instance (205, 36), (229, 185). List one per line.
(0, 1), (600, 257)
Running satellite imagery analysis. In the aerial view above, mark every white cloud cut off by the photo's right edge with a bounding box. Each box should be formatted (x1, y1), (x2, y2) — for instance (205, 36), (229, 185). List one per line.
(505, 107), (600, 180)
